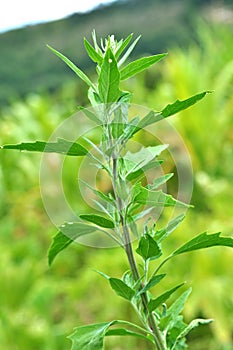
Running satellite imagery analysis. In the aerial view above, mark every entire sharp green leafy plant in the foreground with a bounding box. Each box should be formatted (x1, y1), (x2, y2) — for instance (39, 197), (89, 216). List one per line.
(2, 32), (233, 350)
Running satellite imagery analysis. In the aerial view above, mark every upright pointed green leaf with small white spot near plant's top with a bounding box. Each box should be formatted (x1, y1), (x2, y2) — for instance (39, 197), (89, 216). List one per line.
(98, 48), (120, 103)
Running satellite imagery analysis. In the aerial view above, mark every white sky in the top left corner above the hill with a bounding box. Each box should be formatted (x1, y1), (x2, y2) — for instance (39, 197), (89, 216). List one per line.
(0, 0), (116, 32)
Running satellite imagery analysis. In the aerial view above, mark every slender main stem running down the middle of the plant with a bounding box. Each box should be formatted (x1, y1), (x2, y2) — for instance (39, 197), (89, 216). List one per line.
(112, 154), (166, 350)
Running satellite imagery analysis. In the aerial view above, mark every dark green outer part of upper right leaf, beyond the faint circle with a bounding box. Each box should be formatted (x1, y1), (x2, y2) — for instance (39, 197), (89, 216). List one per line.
(161, 91), (210, 118)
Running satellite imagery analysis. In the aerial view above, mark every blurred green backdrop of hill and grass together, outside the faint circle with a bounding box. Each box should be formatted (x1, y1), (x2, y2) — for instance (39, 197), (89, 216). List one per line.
(0, 0), (233, 350)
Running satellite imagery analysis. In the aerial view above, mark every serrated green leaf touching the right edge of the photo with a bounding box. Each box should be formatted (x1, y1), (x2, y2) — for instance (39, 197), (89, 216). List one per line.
(171, 232), (233, 257)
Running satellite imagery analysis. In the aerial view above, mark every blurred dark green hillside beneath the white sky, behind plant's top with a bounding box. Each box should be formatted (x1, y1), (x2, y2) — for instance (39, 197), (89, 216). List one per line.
(0, 0), (230, 104)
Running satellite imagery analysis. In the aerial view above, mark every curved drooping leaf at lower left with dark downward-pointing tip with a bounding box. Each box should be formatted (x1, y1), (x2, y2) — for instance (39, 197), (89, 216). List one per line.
(48, 222), (98, 265)
